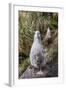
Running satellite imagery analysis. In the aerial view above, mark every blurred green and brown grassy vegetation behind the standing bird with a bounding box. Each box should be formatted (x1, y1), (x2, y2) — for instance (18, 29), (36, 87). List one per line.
(18, 11), (58, 76)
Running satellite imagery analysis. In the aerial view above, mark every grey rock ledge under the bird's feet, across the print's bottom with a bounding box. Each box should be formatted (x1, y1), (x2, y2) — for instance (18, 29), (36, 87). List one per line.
(20, 63), (58, 79)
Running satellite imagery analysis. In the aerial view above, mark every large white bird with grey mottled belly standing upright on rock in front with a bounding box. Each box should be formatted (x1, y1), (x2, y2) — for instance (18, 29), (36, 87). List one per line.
(30, 31), (46, 68)
